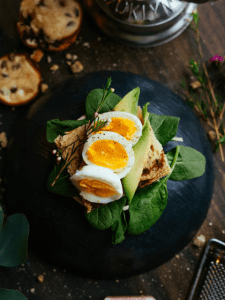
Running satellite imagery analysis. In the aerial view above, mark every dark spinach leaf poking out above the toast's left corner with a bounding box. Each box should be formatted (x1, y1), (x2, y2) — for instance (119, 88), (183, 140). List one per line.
(46, 119), (89, 143)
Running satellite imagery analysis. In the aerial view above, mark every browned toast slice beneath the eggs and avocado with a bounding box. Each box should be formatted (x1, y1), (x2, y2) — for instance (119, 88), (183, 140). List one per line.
(55, 106), (171, 213)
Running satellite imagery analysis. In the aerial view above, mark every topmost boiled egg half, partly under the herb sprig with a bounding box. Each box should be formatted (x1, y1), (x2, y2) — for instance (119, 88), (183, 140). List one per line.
(93, 111), (142, 146)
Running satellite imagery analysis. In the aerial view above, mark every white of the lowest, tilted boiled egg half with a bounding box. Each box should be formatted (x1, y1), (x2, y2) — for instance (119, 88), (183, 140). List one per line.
(70, 165), (123, 204)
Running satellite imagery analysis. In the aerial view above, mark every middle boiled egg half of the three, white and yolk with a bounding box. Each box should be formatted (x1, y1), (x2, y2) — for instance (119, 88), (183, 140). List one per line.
(82, 131), (134, 178)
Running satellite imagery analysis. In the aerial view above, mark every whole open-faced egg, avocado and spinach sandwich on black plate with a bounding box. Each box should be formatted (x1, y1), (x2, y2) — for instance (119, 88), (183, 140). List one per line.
(47, 79), (205, 243)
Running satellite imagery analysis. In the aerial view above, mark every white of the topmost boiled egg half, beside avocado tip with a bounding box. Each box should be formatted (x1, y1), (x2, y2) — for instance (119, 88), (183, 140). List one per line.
(90, 111), (142, 146)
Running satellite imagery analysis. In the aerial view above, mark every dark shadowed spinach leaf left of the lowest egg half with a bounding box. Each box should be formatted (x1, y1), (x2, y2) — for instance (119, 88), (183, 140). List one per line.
(47, 162), (79, 197)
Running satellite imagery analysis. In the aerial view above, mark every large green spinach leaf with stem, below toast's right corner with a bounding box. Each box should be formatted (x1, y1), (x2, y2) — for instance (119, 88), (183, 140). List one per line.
(128, 146), (179, 235)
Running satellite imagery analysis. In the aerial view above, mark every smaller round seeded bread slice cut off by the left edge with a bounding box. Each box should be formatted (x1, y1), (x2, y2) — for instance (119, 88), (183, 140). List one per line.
(0, 53), (41, 106)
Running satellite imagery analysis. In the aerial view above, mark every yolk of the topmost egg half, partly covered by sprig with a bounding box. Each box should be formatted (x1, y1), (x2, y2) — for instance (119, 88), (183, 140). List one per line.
(94, 117), (137, 141)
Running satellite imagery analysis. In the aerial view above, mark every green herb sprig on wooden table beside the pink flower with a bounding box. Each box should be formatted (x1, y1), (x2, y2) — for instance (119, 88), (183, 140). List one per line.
(181, 10), (225, 162)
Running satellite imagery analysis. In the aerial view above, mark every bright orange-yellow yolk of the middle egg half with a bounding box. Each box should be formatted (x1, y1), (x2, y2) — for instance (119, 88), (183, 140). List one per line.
(87, 140), (128, 170)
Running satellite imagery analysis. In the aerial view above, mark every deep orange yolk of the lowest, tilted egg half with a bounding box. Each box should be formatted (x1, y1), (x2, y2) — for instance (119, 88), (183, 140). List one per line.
(79, 179), (116, 197)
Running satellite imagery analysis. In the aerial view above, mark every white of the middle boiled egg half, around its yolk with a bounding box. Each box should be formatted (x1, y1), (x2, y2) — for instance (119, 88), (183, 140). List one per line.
(82, 131), (134, 178)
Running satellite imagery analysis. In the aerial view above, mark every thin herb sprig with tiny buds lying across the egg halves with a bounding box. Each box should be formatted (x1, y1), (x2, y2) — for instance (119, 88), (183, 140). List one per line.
(51, 77), (114, 186)
